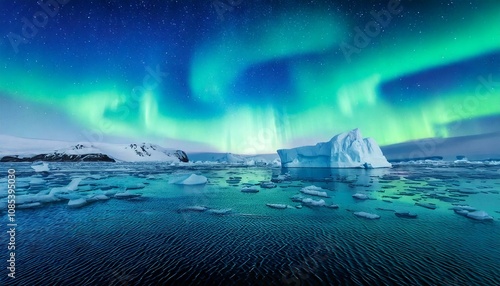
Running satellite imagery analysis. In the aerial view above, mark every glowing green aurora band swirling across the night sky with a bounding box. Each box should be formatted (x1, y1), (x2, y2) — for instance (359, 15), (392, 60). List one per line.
(0, 2), (500, 153)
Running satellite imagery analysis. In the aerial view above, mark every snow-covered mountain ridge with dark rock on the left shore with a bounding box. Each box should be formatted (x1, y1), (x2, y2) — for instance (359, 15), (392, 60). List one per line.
(0, 135), (189, 163)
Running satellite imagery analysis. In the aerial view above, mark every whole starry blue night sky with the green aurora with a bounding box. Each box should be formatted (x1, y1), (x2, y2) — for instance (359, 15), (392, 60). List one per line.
(0, 0), (500, 154)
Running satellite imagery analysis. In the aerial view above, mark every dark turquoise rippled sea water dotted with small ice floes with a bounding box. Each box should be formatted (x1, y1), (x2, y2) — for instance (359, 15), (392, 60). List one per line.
(0, 163), (500, 285)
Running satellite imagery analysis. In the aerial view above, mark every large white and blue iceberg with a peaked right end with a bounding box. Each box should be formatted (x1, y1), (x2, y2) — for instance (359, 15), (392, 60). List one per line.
(278, 129), (392, 168)
